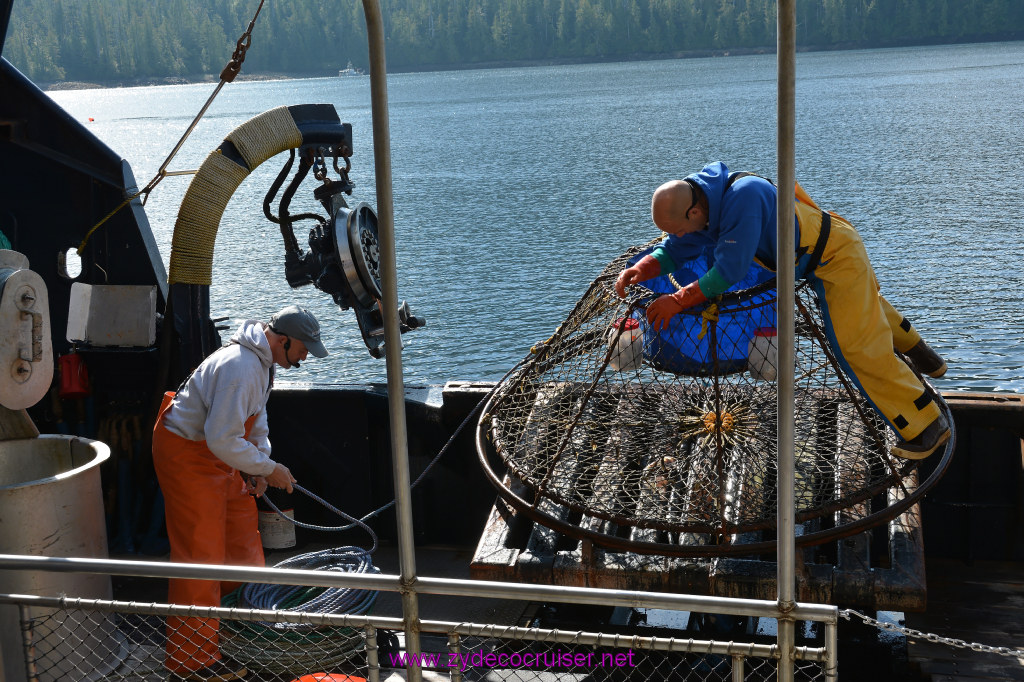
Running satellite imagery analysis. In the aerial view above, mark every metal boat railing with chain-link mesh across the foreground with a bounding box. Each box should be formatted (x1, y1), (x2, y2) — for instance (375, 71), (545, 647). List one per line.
(0, 555), (839, 682)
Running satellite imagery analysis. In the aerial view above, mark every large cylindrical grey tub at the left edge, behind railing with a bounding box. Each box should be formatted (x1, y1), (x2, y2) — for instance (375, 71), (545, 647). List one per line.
(0, 435), (121, 682)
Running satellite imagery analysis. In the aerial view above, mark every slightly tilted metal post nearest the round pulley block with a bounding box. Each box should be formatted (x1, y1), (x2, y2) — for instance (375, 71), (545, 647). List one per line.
(362, 0), (421, 682)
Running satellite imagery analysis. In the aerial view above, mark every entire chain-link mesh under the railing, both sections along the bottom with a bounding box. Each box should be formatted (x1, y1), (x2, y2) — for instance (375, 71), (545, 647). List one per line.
(3, 596), (828, 682)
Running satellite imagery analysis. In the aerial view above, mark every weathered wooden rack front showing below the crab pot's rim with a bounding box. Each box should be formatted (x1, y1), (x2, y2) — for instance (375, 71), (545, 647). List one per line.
(470, 471), (926, 611)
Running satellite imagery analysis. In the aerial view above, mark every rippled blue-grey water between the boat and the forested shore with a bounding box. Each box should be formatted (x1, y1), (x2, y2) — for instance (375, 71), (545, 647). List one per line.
(52, 42), (1024, 392)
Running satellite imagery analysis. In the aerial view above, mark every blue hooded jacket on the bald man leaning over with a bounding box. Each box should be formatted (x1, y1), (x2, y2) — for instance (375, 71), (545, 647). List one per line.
(653, 161), (800, 298)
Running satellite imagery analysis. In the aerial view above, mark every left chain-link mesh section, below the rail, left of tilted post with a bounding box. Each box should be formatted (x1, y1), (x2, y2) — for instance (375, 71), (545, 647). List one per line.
(9, 599), (377, 682)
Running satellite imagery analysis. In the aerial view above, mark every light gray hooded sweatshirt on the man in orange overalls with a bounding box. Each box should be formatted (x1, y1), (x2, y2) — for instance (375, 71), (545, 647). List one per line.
(164, 319), (275, 476)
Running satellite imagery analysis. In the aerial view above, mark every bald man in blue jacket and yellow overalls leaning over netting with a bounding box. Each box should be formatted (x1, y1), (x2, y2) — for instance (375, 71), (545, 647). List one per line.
(615, 162), (949, 460)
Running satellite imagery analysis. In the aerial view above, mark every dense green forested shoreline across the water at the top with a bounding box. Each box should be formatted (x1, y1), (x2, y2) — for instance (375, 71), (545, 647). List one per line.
(4, 0), (1024, 85)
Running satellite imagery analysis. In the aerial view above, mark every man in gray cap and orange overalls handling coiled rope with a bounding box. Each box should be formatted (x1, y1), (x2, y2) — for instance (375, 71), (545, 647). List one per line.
(153, 305), (328, 680)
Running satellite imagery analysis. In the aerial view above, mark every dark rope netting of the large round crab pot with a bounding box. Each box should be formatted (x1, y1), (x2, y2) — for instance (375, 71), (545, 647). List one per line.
(478, 245), (937, 546)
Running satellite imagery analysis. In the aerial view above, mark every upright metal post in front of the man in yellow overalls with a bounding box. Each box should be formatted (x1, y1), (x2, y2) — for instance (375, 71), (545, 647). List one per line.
(775, 0), (797, 682)
